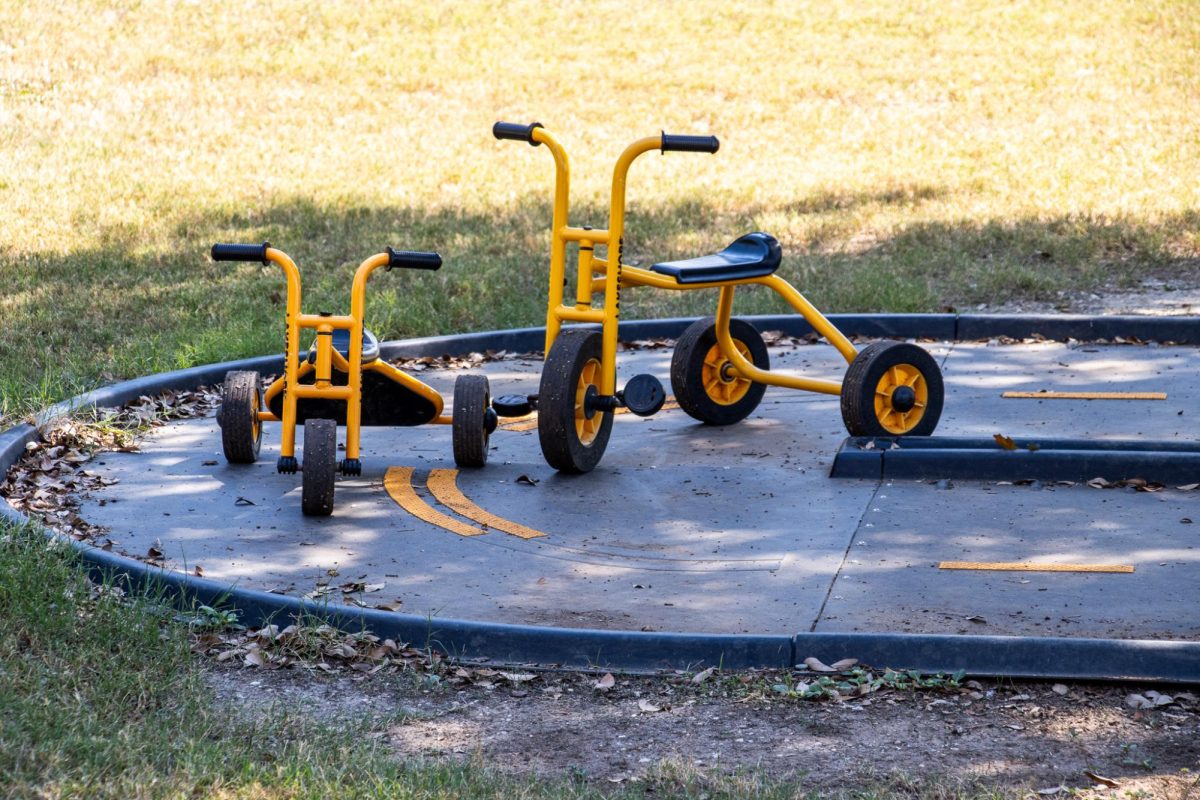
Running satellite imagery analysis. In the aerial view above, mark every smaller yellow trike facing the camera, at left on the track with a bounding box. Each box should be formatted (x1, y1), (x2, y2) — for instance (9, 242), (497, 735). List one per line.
(212, 242), (497, 516)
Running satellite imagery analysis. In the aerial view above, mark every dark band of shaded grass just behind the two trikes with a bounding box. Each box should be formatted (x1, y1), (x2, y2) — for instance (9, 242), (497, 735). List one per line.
(0, 186), (1200, 415)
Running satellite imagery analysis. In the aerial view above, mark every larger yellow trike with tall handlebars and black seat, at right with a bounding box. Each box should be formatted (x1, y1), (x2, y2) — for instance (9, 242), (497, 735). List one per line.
(492, 122), (944, 473)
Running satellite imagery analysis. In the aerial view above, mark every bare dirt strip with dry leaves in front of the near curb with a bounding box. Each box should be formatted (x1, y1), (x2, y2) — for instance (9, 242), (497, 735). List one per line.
(211, 669), (1200, 798)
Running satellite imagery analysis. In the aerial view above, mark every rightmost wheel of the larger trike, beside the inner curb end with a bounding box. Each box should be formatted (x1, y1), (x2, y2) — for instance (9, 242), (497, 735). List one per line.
(841, 342), (946, 437)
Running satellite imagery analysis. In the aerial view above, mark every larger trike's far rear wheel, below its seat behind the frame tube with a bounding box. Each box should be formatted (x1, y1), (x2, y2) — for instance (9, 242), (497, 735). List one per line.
(671, 317), (770, 425)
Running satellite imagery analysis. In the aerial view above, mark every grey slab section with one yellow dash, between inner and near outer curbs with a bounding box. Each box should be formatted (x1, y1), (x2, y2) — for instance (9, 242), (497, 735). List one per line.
(812, 482), (1200, 639)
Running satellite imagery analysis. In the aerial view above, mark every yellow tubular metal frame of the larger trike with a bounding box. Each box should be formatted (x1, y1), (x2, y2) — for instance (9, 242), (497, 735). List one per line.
(532, 127), (858, 395)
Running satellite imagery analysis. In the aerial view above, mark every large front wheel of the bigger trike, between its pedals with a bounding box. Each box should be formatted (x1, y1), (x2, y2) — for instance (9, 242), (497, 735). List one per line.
(538, 331), (612, 474)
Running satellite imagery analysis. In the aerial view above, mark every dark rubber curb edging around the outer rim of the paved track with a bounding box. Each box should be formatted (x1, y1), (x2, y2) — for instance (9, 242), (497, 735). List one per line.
(0, 314), (1200, 684)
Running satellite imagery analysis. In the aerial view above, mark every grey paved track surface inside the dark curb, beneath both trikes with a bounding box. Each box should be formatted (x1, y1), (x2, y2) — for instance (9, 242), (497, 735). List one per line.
(68, 336), (1200, 656)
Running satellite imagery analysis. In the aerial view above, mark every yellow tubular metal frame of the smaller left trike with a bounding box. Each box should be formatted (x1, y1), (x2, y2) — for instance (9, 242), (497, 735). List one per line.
(258, 247), (450, 459)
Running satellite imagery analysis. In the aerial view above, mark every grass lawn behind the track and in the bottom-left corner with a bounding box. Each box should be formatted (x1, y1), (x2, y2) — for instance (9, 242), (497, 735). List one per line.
(0, 0), (1200, 798)
